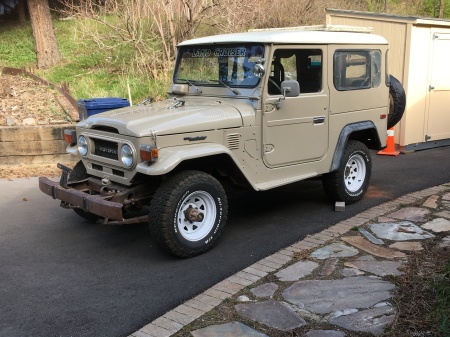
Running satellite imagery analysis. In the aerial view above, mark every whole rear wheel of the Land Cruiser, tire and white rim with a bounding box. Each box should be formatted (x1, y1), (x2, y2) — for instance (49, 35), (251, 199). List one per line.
(322, 140), (372, 204)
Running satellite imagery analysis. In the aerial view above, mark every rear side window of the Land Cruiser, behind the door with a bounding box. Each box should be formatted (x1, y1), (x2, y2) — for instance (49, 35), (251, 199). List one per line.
(333, 50), (381, 91)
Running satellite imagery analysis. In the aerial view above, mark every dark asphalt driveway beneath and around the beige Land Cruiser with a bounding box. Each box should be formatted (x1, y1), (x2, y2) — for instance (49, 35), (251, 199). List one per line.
(0, 147), (450, 337)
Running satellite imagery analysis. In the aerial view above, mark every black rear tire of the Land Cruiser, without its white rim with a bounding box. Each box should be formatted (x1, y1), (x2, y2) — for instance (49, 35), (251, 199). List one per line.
(322, 140), (372, 204)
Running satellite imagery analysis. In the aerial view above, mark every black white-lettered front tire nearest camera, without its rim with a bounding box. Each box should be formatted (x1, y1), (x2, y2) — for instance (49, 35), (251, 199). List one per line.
(149, 170), (228, 258)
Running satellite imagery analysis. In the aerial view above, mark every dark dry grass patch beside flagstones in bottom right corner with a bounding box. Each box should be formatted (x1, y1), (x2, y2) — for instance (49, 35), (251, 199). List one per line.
(383, 236), (450, 337)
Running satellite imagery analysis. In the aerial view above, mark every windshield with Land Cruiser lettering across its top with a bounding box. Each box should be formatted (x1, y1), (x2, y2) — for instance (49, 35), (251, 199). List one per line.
(173, 44), (264, 88)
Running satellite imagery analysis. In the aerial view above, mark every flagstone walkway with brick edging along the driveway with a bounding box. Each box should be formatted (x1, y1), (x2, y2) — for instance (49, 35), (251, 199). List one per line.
(130, 184), (450, 337)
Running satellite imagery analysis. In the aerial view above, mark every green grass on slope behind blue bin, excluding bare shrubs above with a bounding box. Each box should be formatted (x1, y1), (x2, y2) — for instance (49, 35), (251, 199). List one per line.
(0, 19), (170, 104)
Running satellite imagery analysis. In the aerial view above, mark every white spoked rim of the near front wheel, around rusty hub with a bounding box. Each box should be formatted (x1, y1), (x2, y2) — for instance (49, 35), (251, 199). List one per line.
(177, 191), (217, 241)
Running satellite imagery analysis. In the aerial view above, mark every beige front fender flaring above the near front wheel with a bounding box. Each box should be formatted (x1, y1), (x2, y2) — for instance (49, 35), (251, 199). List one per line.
(136, 143), (232, 176)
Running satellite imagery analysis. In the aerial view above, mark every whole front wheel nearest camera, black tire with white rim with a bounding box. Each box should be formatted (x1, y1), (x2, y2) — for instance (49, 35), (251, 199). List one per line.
(149, 171), (228, 258)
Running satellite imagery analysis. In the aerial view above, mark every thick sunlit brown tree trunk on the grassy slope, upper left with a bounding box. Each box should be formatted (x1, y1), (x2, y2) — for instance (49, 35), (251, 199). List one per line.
(28, 0), (61, 68)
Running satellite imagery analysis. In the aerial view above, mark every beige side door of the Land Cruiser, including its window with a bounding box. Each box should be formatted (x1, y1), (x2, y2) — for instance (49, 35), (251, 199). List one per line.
(263, 46), (329, 167)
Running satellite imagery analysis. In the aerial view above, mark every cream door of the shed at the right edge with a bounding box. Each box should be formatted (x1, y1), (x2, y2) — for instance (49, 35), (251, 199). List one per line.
(425, 32), (450, 141)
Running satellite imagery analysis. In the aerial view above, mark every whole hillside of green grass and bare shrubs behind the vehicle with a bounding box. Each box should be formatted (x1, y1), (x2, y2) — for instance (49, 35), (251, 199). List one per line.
(0, 0), (450, 104)
